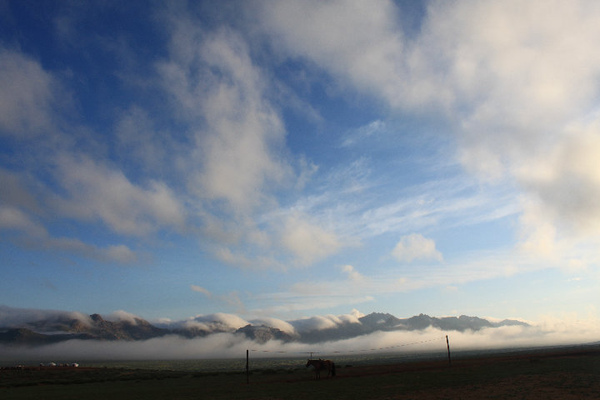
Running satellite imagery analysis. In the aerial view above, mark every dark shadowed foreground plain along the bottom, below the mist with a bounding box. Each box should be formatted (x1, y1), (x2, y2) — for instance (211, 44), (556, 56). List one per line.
(0, 346), (600, 400)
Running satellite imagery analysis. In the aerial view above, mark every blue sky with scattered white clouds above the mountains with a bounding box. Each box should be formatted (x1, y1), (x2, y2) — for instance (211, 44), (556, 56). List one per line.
(0, 0), (600, 338)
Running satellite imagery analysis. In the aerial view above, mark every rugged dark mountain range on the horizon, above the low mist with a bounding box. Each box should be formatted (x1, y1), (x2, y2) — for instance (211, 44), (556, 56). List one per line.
(0, 313), (529, 346)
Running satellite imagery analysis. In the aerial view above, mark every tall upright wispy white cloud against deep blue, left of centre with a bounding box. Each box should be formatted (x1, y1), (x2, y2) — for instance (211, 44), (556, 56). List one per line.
(159, 21), (291, 215)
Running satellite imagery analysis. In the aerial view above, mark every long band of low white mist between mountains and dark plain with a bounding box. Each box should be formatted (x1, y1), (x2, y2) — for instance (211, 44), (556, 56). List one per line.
(0, 322), (600, 362)
